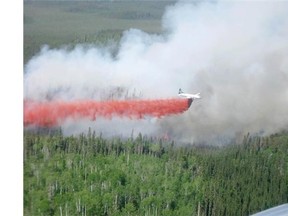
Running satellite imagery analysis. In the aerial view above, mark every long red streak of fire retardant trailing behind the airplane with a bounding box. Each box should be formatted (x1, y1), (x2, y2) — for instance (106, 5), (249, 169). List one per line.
(24, 99), (192, 127)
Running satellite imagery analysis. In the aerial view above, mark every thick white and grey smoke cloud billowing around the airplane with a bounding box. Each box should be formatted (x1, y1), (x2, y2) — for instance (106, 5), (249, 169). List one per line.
(24, 1), (288, 143)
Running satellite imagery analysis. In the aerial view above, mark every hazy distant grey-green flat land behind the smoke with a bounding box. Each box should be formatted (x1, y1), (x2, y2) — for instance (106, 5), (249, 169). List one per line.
(24, 1), (173, 63)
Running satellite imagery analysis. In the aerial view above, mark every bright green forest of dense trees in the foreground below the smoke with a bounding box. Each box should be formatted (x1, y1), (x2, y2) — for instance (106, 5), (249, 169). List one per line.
(24, 130), (288, 216)
